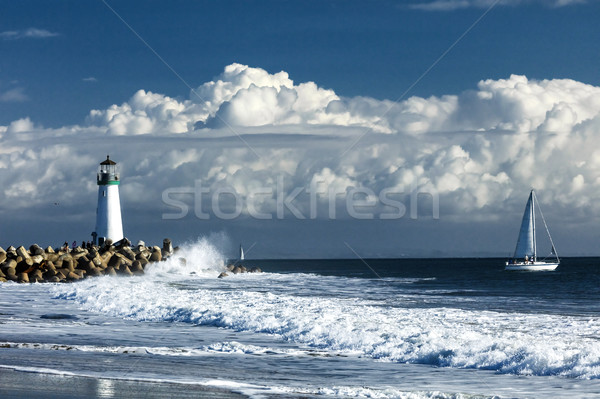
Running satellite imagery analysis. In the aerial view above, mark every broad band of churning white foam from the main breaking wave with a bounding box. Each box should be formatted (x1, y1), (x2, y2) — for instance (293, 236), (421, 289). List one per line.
(55, 239), (600, 379)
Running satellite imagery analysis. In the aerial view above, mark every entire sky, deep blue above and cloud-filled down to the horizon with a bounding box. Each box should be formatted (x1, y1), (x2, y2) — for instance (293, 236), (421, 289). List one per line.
(0, 0), (600, 258)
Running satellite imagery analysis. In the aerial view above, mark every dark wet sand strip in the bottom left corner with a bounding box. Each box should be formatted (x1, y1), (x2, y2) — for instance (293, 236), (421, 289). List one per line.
(0, 368), (246, 399)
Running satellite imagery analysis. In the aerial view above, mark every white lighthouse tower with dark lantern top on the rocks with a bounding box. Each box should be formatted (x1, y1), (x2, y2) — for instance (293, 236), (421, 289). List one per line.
(92, 155), (123, 245)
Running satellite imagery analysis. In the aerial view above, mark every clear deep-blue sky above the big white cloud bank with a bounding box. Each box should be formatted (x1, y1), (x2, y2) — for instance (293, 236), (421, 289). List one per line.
(0, 0), (600, 126)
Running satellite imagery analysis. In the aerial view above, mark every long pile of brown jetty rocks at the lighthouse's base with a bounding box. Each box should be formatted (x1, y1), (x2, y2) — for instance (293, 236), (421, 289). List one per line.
(0, 238), (177, 283)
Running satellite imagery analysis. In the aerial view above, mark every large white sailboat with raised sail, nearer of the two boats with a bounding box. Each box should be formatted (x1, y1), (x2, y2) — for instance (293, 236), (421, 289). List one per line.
(504, 190), (560, 271)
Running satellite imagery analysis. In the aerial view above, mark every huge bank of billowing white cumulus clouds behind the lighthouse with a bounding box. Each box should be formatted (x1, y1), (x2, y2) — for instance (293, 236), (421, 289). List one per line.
(0, 64), (600, 253)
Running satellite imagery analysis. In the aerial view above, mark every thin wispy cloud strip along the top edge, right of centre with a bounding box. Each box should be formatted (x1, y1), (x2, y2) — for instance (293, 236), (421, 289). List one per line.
(410, 0), (587, 11)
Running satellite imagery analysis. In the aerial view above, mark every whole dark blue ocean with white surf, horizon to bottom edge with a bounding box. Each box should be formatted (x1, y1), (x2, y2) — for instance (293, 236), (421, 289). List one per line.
(0, 239), (600, 399)
